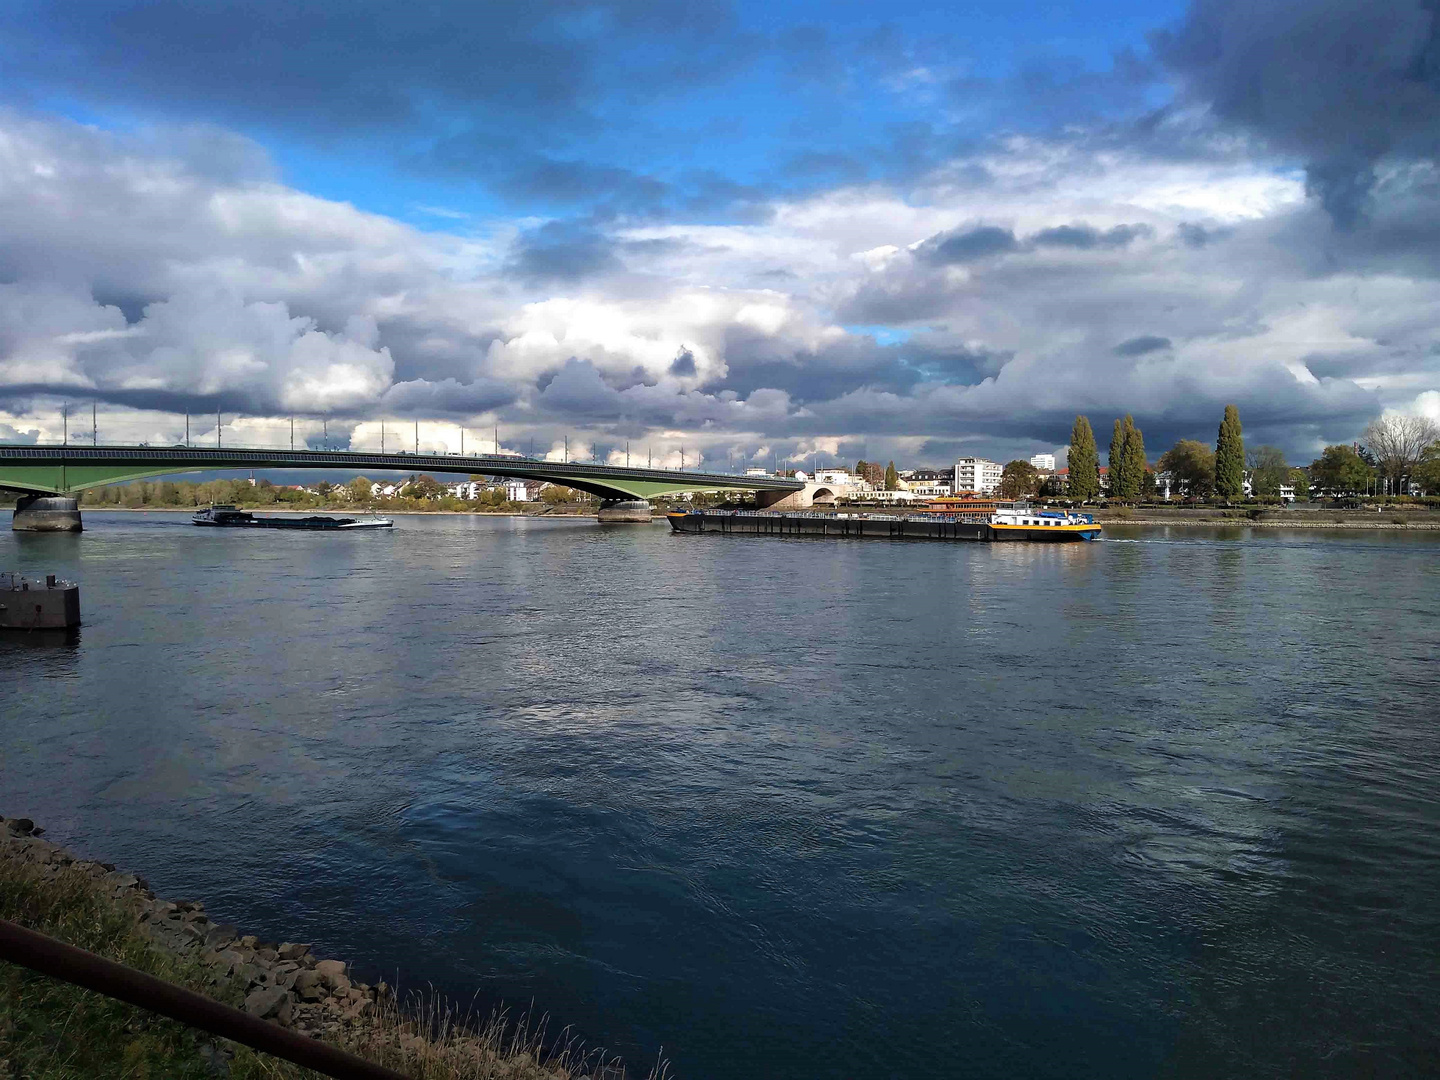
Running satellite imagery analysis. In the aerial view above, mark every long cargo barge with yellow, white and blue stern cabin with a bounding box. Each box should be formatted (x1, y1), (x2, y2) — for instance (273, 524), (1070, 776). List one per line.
(667, 503), (1100, 543)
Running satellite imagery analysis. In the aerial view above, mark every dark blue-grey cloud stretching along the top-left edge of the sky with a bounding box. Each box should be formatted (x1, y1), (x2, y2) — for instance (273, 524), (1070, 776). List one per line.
(0, 0), (744, 132)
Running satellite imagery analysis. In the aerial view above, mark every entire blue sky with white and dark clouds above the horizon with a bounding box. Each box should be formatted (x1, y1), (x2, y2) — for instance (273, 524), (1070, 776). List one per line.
(0, 0), (1440, 468)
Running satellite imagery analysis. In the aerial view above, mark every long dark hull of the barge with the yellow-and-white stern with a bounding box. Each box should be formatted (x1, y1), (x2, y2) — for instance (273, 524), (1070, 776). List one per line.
(667, 510), (1100, 543)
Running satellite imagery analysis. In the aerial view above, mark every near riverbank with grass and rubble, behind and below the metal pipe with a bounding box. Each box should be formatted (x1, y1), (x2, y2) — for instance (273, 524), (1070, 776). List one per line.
(0, 818), (670, 1080)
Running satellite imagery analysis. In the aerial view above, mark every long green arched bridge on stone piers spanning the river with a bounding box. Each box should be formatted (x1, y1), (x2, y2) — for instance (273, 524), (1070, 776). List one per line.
(0, 446), (804, 528)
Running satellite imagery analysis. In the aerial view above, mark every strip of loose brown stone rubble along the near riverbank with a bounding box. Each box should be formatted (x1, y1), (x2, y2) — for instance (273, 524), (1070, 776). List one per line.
(0, 818), (390, 1037)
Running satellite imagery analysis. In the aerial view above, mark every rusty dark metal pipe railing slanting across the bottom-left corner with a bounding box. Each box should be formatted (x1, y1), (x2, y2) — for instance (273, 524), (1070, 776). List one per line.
(0, 919), (409, 1080)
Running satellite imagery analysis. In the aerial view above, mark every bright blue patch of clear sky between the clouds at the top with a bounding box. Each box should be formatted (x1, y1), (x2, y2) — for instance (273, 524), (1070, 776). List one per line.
(22, 0), (1184, 230)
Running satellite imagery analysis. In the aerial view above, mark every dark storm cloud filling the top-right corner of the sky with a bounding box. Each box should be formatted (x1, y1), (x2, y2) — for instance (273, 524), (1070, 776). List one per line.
(1152, 0), (1440, 228)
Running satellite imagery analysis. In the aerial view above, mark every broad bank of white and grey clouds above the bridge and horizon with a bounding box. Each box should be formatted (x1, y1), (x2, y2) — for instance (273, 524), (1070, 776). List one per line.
(0, 105), (1440, 462)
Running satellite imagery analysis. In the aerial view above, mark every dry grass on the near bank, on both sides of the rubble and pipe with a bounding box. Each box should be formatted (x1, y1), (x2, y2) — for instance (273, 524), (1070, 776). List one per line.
(0, 857), (670, 1080)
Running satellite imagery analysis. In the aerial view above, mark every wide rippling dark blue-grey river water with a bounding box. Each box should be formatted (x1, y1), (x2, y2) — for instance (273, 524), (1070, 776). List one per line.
(0, 511), (1440, 1080)
